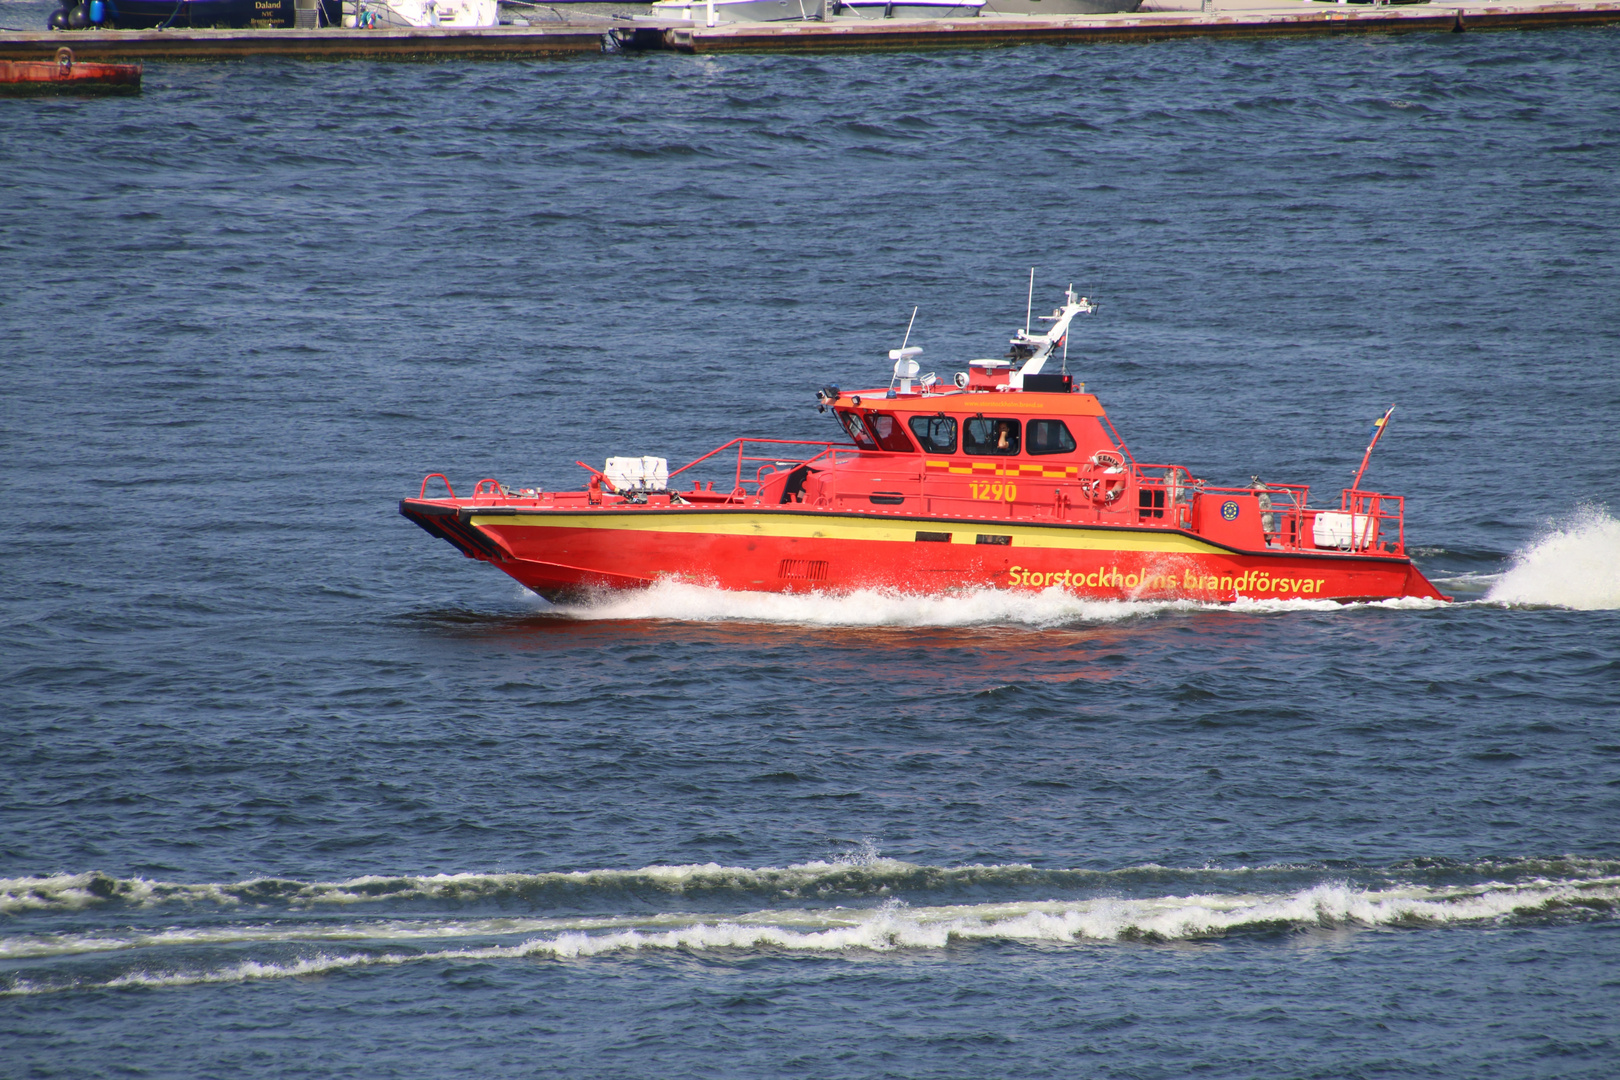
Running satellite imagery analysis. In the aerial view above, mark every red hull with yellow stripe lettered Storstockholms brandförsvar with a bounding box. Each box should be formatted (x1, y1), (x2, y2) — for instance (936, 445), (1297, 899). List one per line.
(400, 499), (1445, 602)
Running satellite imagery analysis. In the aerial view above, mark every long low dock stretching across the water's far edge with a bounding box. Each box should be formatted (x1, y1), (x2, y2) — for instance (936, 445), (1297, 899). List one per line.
(0, 0), (1620, 60)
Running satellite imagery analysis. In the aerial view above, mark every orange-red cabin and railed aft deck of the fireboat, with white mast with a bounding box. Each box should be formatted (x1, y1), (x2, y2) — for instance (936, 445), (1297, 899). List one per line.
(745, 288), (1401, 551)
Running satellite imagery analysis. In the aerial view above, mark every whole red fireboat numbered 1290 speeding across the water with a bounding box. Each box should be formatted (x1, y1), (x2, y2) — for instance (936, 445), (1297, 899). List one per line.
(400, 287), (1450, 602)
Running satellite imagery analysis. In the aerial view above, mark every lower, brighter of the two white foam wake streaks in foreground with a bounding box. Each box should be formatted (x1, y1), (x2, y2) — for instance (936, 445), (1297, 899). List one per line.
(0, 878), (1620, 996)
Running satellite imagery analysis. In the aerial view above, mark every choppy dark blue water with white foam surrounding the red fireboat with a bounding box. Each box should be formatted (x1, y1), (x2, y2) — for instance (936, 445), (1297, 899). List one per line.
(0, 31), (1620, 1077)
